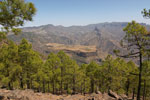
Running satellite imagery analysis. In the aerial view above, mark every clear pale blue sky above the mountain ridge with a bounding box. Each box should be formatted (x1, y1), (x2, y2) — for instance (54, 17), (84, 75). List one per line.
(25, 0), (150, 27)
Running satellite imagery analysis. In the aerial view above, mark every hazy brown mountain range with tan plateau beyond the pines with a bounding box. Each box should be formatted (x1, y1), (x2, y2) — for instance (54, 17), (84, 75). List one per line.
(8, 22), (149, 63)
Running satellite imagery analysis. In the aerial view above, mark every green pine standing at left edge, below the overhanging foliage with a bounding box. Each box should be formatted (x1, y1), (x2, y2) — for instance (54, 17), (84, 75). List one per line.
(0, 41), (22, 89)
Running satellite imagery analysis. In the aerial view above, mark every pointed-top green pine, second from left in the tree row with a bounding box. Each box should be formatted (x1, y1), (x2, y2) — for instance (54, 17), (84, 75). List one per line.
(18, 39), (42, 89)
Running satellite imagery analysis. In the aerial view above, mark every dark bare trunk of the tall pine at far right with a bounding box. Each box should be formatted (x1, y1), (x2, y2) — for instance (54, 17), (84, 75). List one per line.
(137, 52), (142, 100)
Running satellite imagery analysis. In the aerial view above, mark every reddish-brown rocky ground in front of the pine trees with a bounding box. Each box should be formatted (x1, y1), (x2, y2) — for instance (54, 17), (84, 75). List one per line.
(0, 89), (128, 100)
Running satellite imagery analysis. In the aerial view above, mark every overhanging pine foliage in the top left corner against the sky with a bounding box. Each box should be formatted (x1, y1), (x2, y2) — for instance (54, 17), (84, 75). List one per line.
(0, 0), (36, 35)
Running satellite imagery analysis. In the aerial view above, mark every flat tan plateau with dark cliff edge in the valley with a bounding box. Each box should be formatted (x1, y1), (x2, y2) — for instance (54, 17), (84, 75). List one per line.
(45, 43), (101, 63)
